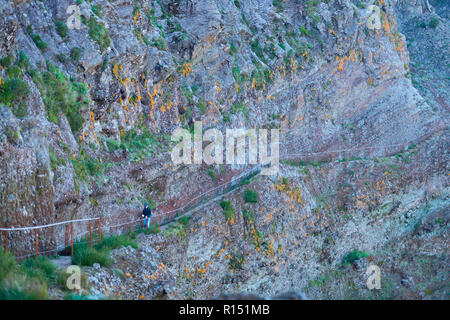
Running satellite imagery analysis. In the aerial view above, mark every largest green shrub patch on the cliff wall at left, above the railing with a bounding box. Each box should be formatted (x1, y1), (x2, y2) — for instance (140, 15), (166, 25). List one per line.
(30, 62), (89, 133)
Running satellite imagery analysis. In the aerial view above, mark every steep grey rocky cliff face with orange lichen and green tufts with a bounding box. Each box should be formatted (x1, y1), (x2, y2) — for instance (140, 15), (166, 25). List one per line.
(0, 0), (449, 298)
